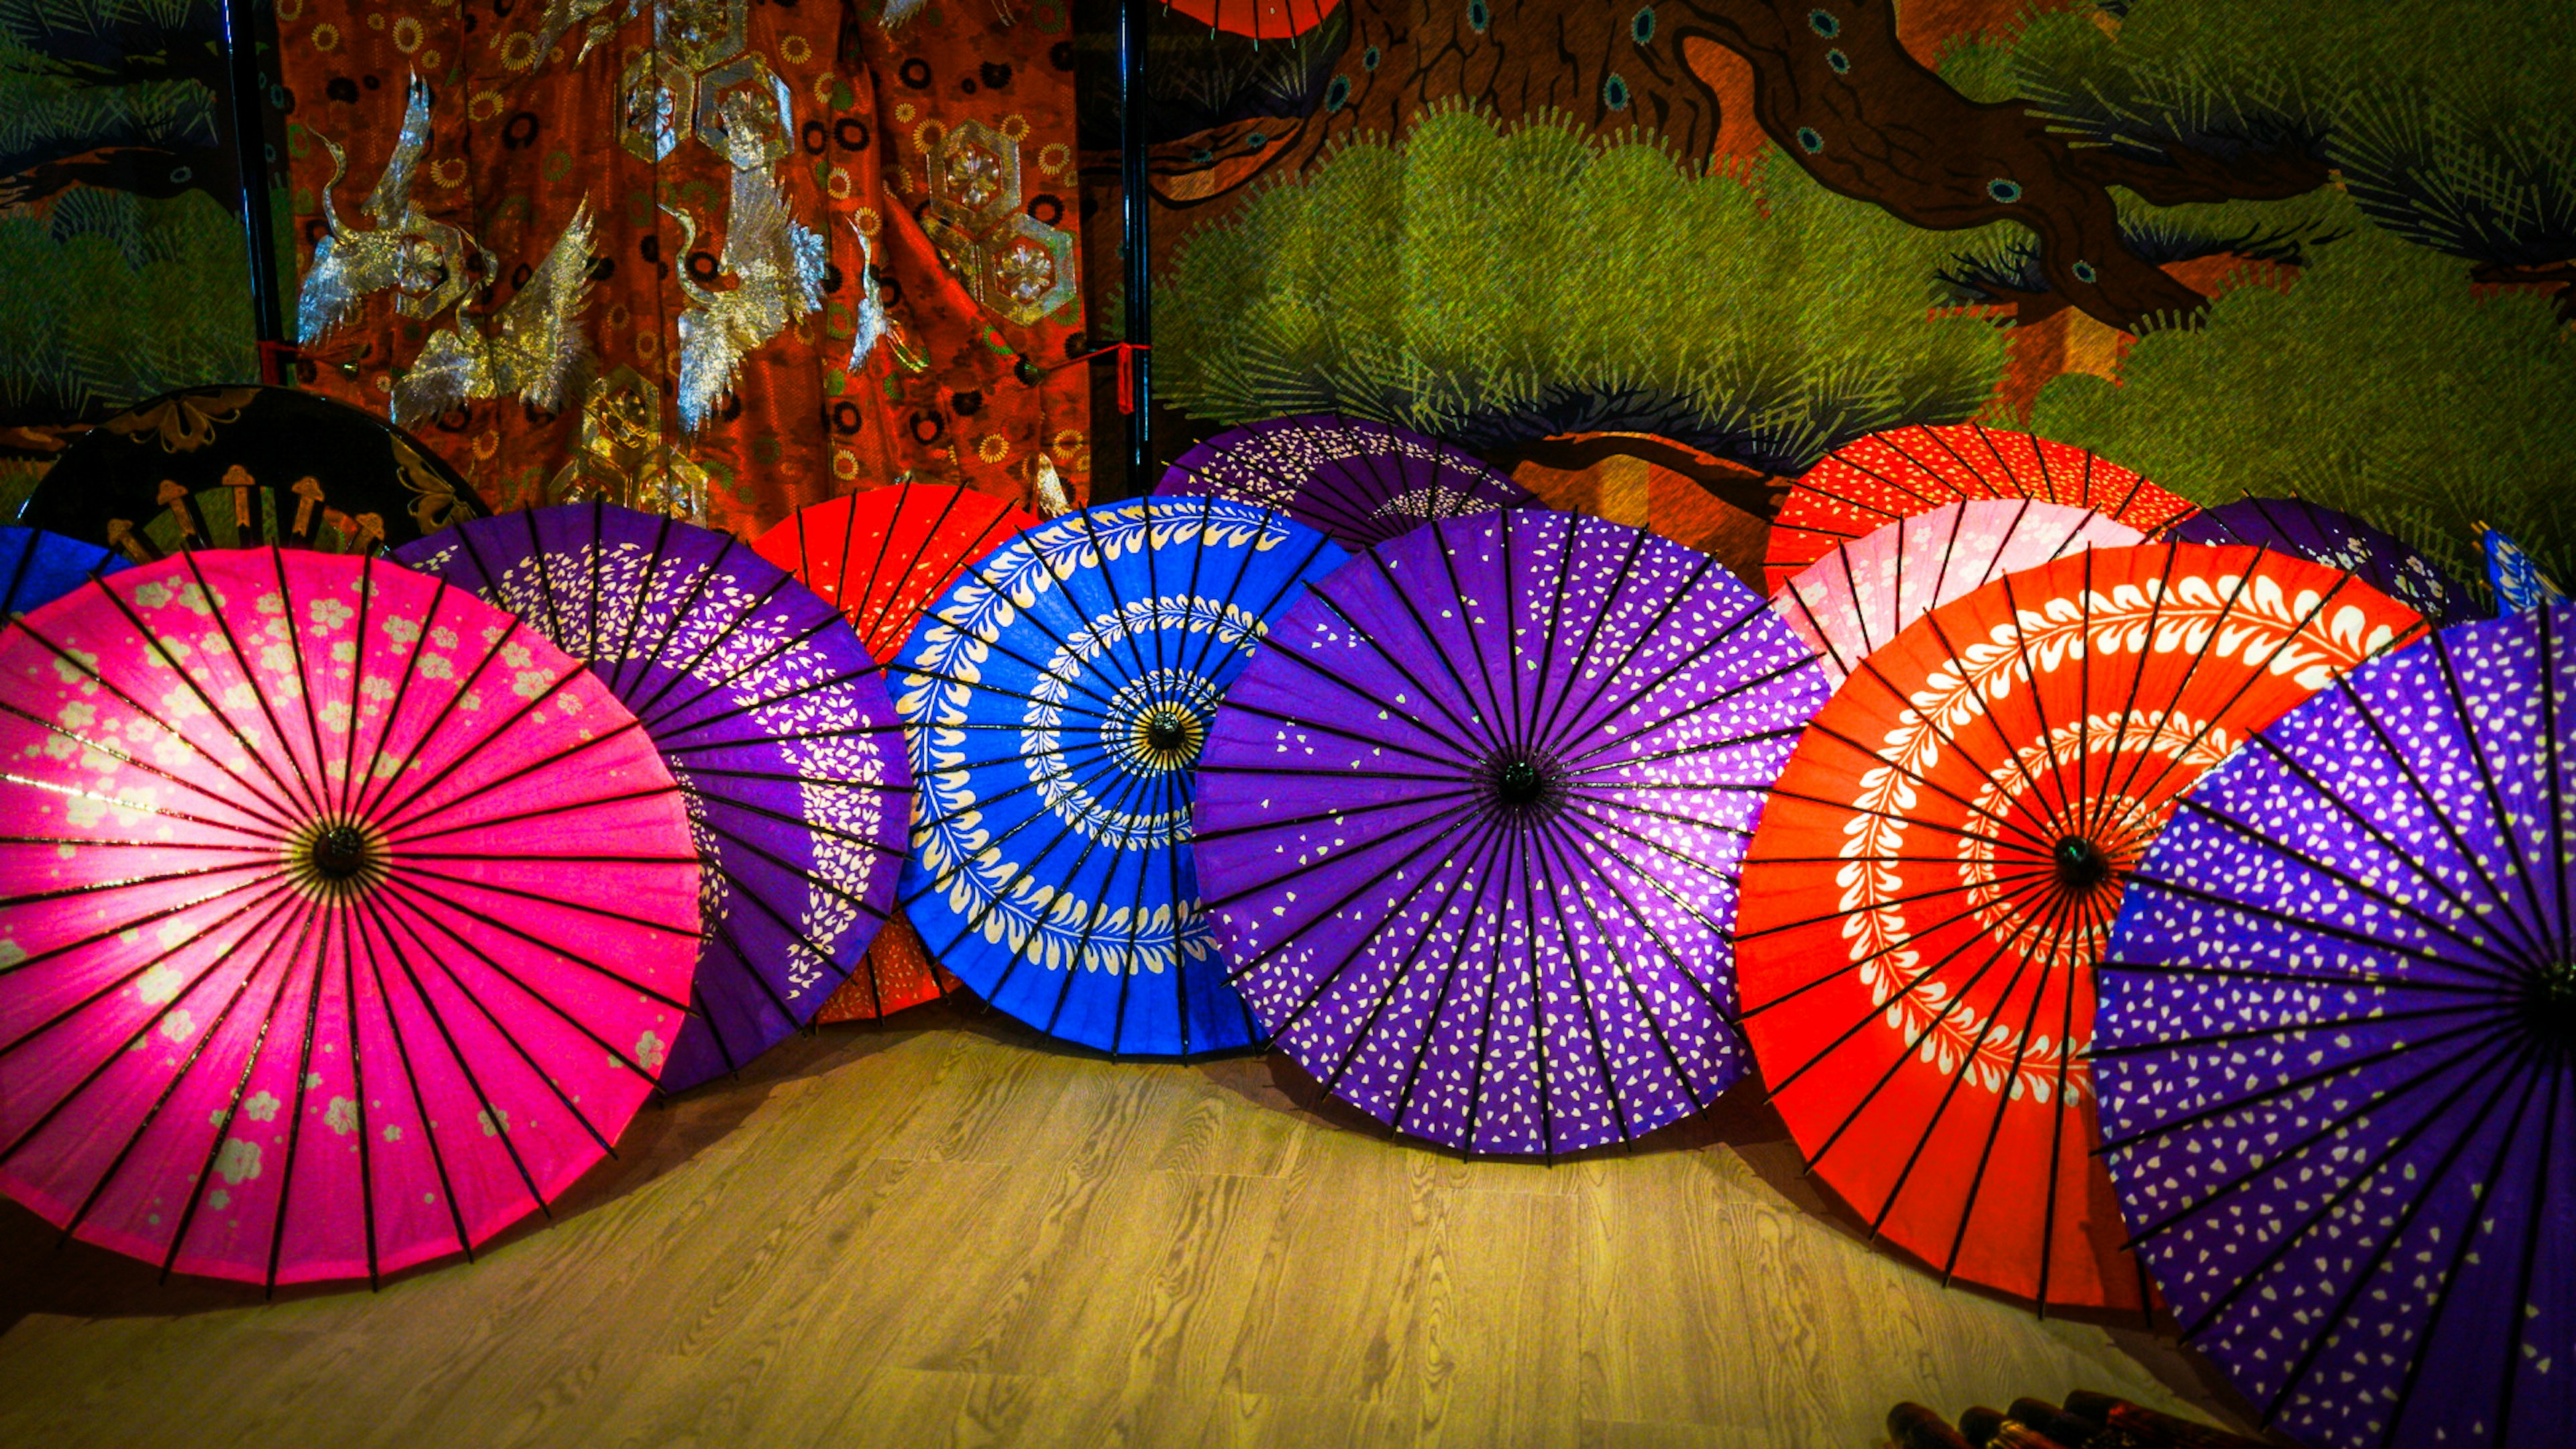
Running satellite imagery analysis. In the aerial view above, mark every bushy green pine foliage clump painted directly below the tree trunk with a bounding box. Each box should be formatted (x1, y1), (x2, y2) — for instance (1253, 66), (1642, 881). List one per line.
(1154, 108), (2004, 472)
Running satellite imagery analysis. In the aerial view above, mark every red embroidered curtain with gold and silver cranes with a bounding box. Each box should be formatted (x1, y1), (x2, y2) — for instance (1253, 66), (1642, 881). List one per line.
(276, 0), (1089, 531)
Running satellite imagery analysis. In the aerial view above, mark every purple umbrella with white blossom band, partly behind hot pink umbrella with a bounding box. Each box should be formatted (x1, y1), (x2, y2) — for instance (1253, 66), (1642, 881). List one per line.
(394, 502), (912, 1091)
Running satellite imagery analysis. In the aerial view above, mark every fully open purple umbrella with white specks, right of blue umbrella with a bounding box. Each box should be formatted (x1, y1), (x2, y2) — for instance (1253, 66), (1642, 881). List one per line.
(1198, 511), (1827, 1155)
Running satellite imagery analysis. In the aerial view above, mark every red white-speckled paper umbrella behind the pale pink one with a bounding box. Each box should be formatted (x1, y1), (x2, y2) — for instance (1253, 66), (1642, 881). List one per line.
(1762, 423), (2195, 593)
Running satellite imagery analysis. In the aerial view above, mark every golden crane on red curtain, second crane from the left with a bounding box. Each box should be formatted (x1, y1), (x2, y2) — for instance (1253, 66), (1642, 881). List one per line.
(394, 196), (590, 423)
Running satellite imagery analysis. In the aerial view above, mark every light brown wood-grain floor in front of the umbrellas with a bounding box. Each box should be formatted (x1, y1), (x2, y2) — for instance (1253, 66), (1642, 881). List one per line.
(0, 1006), (2256, 1449)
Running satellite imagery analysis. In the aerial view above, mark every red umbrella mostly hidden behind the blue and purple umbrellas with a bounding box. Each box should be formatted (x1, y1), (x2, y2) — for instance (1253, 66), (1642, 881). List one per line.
(752, 482), (1038, 1021)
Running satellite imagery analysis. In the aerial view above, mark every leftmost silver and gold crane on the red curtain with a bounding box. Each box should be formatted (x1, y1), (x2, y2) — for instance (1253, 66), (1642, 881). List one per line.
(297, 74), (494, 343)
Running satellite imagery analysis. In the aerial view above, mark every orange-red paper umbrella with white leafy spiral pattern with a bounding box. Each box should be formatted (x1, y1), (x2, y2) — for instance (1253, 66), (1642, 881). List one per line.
(1736, 544), (2422, 1309)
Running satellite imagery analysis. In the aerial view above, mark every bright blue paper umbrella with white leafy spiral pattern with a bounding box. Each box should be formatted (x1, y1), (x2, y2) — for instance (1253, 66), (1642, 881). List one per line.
(894, 498), (1344, 1055)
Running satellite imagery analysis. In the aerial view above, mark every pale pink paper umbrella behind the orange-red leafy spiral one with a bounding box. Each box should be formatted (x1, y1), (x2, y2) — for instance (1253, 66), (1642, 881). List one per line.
(1772, 498), (2146, 688)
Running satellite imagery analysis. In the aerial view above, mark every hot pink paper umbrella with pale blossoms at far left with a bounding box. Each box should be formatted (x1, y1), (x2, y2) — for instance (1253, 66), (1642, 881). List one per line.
(0, 549), (698, 1284)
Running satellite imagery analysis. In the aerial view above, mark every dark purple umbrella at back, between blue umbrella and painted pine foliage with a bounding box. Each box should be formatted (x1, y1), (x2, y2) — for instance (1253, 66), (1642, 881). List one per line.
(1154, 413), (1538, 549)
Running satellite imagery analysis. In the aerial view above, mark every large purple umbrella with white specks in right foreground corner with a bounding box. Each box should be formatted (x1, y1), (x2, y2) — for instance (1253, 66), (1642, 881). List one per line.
(2094, 606), (2576, 1449)
